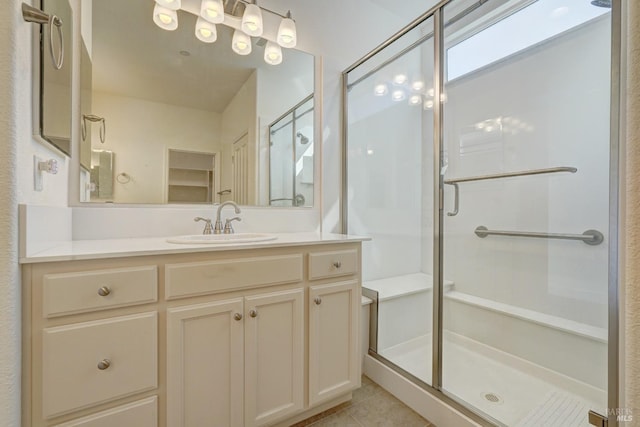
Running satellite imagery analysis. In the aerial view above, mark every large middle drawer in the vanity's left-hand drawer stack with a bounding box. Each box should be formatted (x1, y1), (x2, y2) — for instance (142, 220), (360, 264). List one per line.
(42, 312), (158, 418)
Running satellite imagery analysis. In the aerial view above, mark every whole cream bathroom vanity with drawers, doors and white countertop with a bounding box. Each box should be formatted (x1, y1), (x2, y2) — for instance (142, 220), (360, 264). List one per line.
(22, 233), (362, 427)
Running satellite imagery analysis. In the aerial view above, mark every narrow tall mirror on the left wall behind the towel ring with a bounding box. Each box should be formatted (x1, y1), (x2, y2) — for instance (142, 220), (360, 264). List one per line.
(39, 0), (73, 155)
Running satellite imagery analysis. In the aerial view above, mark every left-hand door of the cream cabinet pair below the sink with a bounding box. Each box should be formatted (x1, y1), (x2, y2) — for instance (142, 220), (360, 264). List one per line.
(167, 298), (244, 427)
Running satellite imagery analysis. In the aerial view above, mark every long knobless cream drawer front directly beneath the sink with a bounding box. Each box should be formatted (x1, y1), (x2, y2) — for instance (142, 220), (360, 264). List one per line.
(165, 254), (302, 299)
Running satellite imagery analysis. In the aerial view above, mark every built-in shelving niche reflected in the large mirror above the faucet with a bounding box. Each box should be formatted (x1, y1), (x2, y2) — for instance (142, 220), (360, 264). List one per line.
(167, 149), (220, 203)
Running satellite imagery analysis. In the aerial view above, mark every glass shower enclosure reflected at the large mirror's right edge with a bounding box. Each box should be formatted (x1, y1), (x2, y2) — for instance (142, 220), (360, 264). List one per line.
(269, 95), (314, 207)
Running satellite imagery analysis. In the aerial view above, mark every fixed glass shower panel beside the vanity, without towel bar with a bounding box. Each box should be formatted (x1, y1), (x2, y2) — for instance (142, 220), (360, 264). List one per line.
(347, 15), (434, 384)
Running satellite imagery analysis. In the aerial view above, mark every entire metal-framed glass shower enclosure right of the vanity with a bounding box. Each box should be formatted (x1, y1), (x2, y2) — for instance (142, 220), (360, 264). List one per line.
(343, 0), (619, 427)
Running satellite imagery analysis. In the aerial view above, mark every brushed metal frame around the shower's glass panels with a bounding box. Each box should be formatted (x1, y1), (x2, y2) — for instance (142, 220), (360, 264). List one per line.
(340, 0), (628, 427)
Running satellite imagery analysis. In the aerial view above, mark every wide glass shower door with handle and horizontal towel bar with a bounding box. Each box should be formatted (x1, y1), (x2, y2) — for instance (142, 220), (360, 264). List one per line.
(442, 0), (611, 427)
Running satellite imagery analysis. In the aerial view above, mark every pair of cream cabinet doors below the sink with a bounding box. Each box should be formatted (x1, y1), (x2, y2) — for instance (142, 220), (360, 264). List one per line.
(167, 288), (304, 427)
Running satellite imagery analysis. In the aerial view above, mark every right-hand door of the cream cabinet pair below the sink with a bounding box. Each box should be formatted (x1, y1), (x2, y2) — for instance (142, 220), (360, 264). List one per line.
(244, 289), (304, 427)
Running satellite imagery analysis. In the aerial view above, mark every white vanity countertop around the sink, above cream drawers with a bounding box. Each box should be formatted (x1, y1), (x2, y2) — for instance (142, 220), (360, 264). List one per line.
(20, 233), (370, 264)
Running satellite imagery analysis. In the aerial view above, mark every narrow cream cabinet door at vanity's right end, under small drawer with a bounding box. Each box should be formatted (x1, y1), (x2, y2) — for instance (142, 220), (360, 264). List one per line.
(309, 281), (361, 405)
